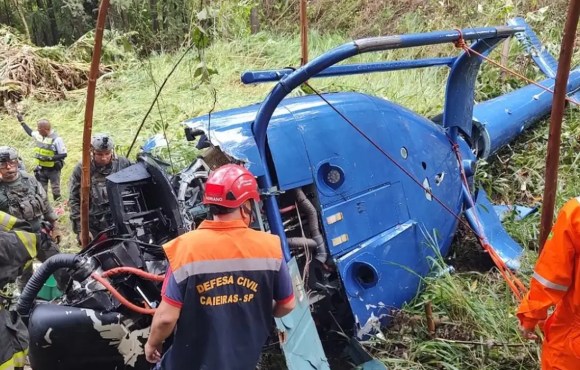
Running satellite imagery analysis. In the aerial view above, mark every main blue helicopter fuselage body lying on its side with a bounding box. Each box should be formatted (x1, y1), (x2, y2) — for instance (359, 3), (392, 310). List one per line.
(186, 93), (466, 327)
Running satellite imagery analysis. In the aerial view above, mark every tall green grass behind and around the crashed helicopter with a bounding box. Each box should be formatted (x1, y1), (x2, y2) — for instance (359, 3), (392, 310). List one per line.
(0, 8), (580, 369)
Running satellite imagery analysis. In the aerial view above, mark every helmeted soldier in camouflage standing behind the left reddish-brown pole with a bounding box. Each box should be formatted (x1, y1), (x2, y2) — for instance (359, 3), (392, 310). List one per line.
(69, 134), (131, 239)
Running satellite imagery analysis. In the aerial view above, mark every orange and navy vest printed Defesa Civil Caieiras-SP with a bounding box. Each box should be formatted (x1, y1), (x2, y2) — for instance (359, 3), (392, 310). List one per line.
(161, 220), (291, 370)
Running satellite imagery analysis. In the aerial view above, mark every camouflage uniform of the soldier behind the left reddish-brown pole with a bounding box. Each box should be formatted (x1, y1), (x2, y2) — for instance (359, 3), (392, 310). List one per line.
(69, 157), (131, 236)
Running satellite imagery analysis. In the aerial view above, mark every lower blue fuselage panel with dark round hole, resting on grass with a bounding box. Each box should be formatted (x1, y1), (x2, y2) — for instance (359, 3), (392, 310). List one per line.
(336, 221), (420, 338)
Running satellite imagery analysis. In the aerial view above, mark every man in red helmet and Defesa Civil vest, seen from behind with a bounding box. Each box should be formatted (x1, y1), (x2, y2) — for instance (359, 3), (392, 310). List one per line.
(145, 164), (295, 370)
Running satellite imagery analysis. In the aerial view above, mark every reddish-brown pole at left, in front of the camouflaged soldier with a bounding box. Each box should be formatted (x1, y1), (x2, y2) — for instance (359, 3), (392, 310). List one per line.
(80, 0), (109, 249)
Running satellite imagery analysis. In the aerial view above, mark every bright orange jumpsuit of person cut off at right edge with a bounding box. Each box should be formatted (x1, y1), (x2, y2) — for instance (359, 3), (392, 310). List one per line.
(517, 197), (580, 370)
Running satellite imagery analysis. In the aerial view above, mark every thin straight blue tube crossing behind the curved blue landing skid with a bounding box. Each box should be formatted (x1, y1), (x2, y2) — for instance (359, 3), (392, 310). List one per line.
(241, 58), (455, 84)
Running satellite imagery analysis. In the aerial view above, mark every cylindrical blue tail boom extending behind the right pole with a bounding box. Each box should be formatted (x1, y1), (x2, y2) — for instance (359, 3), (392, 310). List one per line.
(473, 69), (580, 158)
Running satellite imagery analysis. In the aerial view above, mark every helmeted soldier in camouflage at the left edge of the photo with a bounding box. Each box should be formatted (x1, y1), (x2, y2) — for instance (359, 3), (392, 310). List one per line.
(0, 146), (62, 289)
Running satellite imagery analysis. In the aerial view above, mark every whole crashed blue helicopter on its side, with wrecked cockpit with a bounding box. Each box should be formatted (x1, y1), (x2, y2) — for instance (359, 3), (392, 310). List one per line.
(18, 18), (580, 370)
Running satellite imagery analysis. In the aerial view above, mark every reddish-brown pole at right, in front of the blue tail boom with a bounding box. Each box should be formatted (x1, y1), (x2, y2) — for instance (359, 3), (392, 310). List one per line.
(540, 0), (580, 251)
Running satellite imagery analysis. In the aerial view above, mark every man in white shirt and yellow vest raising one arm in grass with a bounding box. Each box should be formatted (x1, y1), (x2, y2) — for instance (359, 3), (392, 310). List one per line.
(16, 113), (67, 201)
